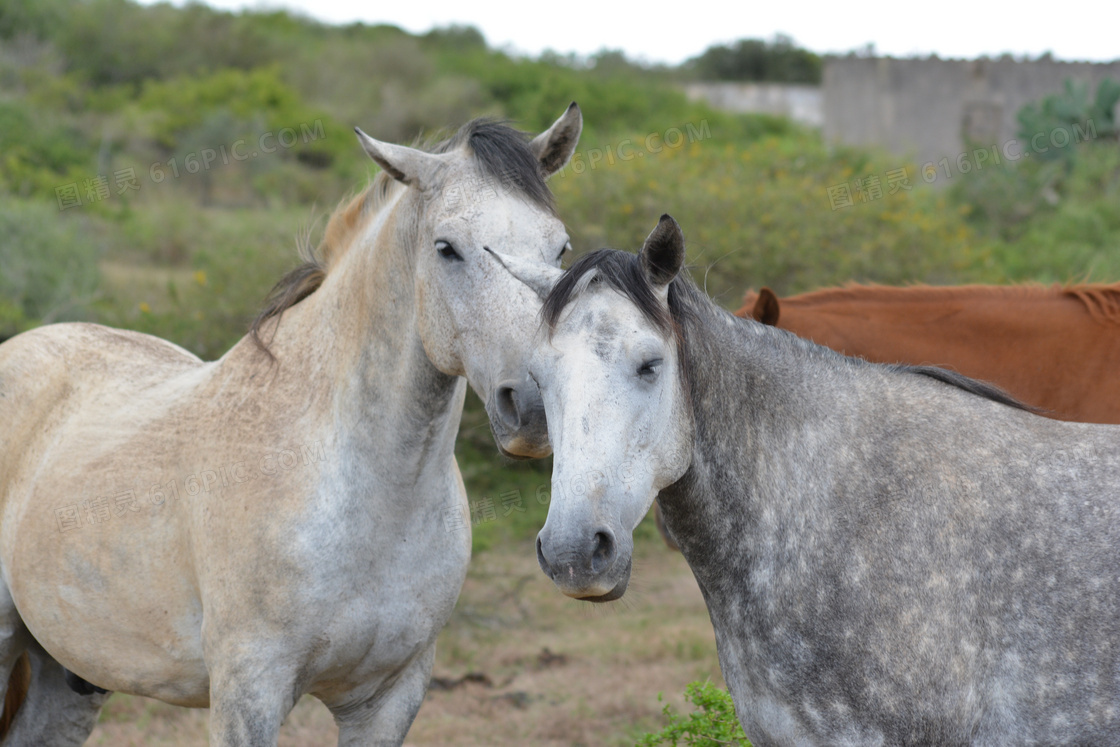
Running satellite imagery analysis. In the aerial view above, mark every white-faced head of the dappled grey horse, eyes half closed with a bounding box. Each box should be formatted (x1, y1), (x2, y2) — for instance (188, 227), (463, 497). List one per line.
(502, 215), (694, 601)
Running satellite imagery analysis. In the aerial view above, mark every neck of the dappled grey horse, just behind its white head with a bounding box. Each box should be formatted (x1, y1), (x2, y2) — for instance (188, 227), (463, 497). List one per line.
(659, 292), (876, 586)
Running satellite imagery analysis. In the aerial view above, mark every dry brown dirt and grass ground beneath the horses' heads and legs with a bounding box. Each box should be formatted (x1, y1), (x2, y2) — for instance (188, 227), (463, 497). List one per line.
(87, 540), (722, 747)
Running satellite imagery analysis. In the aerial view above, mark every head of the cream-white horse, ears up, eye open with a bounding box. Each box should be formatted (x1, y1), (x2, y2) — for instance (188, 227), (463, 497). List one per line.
(357, 103), (582, 458)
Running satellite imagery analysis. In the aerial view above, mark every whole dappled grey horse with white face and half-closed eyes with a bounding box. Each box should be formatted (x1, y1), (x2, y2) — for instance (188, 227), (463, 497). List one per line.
(503, 216), (1120, 747)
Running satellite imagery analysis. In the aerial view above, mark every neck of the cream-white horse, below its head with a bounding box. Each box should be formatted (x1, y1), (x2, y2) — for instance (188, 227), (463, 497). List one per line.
(227, 192), (466, 489)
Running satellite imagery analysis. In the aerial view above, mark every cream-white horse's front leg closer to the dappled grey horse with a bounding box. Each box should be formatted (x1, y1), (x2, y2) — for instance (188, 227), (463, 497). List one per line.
(327, 643), (436, 747)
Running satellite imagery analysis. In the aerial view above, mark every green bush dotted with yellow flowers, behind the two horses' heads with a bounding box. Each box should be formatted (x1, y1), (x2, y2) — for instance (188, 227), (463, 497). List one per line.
(550, 128), (978, 308)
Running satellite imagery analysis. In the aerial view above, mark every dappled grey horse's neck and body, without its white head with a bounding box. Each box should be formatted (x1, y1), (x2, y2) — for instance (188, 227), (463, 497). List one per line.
(659, 281), (1120, 747)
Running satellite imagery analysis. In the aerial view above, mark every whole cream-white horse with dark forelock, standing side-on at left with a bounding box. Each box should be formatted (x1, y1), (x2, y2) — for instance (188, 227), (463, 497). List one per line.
(0, 104), (582, 746)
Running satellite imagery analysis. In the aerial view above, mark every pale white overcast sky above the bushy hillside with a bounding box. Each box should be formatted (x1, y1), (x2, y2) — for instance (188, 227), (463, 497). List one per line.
(146, 0), (1120, 64)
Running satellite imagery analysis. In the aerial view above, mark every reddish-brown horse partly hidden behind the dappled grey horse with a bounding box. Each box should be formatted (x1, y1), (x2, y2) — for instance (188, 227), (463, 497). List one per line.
(655, 283), (1120, 549)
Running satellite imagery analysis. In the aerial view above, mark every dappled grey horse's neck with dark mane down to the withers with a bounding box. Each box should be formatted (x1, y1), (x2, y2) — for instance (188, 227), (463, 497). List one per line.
(659, 279), (1029, 585)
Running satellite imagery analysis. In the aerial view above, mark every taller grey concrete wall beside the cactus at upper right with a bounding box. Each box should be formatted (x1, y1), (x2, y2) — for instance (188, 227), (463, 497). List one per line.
(822, 57), (1120, 165)
